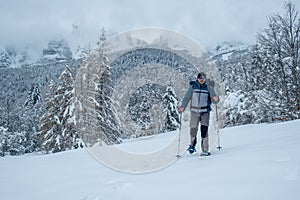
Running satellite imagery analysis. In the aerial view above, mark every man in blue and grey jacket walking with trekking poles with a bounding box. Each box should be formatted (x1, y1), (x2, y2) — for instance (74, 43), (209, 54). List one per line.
(179, 72), (219, 156)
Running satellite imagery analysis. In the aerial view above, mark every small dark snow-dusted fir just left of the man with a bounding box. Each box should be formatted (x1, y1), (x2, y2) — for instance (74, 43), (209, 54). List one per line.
(163, 86), (180, 131)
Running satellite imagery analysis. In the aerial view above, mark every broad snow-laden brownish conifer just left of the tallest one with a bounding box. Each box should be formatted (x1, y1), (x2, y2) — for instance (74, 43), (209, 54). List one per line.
(39, 67), (83, 153)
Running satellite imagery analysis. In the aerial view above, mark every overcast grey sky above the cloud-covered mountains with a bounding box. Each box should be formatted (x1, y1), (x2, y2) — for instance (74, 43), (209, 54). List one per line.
(0, 0), (300, 57)
